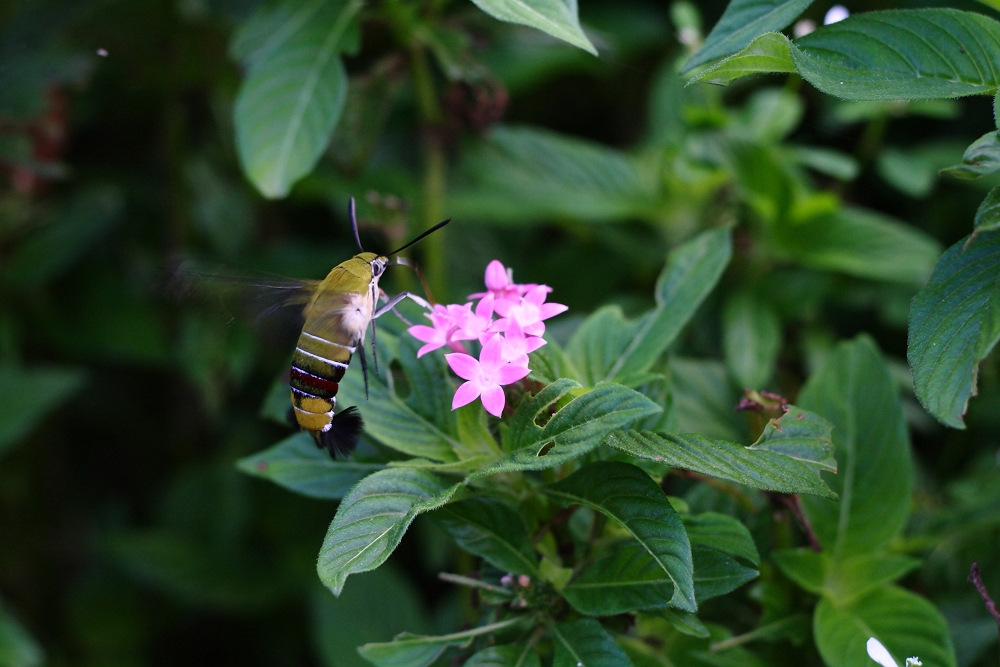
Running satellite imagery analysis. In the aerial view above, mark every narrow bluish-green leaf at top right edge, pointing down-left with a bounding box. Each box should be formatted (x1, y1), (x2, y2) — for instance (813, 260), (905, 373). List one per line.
(681, 0), (812, 74)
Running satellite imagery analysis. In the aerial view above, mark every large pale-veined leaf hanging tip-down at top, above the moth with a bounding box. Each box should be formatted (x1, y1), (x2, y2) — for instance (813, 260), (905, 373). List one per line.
(234, 0), (362, 199)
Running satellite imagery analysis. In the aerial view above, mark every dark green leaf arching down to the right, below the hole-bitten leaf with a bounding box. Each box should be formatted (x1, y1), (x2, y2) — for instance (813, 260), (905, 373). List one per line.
(545, 461), (697, 611)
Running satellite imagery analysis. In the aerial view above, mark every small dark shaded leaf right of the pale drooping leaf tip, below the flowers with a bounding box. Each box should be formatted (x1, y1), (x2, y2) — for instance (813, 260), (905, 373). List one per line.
(433, 498), (538, 577)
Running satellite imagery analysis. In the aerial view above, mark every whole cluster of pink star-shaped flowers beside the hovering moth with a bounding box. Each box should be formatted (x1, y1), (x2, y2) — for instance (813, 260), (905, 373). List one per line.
(408, 260), (567, 417)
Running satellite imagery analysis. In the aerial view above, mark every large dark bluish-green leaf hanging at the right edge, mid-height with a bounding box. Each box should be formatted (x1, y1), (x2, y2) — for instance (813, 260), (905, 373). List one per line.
(906, 231), (1000, 428)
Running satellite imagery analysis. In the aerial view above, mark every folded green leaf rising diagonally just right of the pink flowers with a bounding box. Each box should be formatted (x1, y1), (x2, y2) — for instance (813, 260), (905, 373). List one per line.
(566, 228), (732, 384)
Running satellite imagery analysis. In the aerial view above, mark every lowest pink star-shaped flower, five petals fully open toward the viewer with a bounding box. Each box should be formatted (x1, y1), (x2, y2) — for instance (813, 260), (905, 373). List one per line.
(444, 334), (531, 417)
